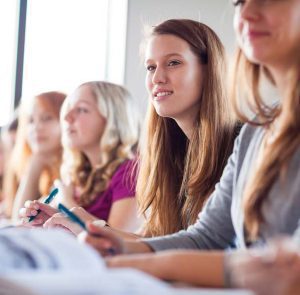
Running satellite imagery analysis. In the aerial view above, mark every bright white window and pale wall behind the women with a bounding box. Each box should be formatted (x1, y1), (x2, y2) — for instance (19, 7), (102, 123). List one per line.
(0, 0), (235, 126)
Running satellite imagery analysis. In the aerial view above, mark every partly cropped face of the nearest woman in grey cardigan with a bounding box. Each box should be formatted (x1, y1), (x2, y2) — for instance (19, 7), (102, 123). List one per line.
(233, 0), (300, 66)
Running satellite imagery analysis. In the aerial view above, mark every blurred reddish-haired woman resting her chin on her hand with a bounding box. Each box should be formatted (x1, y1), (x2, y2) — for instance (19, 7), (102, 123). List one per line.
(3, 91), (66, 218)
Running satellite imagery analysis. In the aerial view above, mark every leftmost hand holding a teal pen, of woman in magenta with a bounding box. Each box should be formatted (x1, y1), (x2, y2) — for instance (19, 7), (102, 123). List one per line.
(19, 201), (58, 227)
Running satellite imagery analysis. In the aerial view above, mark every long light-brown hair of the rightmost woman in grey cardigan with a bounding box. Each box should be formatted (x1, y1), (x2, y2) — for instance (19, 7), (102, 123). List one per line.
(231, 49), (300, 241)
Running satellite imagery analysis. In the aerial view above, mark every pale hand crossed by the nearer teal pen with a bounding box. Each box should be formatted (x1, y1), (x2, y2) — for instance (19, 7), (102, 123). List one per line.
(44, 207), (97, 235)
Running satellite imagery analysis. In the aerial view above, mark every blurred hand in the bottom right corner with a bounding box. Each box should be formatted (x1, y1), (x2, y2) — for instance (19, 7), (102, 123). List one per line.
(228, 240), (300, 295)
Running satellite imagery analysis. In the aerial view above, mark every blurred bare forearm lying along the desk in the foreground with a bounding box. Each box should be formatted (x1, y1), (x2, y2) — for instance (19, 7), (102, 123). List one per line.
(106, 251), (224, 287)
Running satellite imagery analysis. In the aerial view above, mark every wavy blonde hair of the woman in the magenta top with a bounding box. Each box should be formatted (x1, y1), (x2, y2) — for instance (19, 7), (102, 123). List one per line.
(61, 81), (140, 206)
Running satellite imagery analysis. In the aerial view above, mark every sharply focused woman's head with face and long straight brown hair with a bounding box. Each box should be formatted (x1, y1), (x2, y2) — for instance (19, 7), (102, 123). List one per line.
(137, 19), (236, 236)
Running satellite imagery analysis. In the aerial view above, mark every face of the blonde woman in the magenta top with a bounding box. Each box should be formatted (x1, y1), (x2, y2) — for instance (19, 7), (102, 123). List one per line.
(62, 86), (106, 152)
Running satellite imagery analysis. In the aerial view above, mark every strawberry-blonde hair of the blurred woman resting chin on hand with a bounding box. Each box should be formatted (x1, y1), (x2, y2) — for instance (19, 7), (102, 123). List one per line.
(4, 91), (66, 216)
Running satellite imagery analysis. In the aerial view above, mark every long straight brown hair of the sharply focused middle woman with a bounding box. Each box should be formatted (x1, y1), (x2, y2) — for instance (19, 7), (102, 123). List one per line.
(137, 19), (238, 236)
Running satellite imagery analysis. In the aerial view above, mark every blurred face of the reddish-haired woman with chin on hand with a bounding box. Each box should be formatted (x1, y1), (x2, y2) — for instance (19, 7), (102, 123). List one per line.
(27, 103), (61, 154)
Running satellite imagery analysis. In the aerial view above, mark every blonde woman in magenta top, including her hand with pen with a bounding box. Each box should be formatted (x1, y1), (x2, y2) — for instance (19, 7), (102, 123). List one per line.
(20, 82), (140, 231)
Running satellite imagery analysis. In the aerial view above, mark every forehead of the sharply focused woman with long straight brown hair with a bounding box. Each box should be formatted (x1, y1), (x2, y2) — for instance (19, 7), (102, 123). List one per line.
(145, 34), (194, 61)
